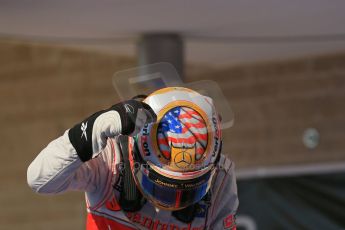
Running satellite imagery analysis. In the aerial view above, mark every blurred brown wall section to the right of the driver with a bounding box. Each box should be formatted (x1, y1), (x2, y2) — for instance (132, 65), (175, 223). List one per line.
(188, 54), (345, 168)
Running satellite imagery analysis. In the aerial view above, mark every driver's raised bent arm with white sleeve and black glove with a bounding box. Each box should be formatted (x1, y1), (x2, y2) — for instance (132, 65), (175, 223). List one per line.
(27, 100), (155, 194)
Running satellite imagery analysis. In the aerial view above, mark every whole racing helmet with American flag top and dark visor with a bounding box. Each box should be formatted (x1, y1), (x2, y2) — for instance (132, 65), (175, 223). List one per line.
(130, 87), (221, 210)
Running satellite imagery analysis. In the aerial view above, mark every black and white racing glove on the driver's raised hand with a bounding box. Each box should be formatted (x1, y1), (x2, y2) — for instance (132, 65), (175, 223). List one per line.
(68, 100), (157, 161)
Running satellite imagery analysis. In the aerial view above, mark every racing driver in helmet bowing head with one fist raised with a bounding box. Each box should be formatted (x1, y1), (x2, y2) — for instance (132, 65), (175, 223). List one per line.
(27, 87), (238, 230)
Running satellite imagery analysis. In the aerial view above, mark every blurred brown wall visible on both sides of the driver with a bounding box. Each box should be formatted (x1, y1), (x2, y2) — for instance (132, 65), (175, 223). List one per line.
(0, 38), (345, 230)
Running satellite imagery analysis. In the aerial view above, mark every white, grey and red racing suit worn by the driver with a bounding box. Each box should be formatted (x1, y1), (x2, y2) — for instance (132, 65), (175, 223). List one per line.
(27, 131), (238, 230)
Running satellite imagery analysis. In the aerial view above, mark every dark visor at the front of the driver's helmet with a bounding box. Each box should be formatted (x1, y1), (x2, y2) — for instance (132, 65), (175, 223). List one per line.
(135, 164), (214, 210)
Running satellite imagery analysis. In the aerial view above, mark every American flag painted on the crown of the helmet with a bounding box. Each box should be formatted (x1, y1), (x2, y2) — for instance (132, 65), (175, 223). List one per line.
(157, 106), (208, 161)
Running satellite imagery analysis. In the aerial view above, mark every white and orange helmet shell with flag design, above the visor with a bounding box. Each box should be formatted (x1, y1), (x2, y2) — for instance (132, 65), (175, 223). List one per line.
(136, 87), (221, 175)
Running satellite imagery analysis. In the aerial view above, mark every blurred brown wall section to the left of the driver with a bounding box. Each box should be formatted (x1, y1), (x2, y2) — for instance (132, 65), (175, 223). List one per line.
(0, 42), (135, 230)
